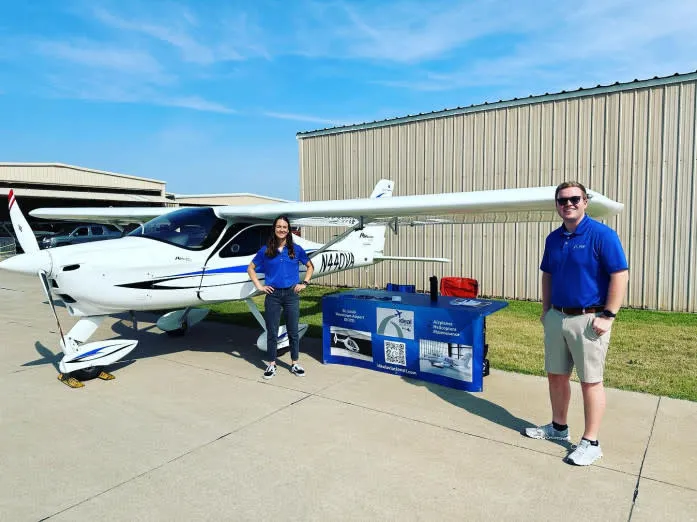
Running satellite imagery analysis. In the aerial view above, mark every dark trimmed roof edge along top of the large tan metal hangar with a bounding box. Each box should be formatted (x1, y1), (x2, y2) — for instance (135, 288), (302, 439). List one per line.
(295, 71), (697, 139)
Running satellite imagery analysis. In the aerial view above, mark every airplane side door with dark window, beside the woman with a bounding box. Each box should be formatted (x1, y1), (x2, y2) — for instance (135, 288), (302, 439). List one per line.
(199, 224), (270, 302)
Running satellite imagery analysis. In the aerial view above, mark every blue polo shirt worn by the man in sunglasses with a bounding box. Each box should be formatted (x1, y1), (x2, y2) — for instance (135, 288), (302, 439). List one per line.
(540, 216), (628, 308)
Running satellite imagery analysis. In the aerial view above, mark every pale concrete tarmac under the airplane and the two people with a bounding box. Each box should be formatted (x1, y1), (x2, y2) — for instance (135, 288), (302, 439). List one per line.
(0, 272), (697, 522)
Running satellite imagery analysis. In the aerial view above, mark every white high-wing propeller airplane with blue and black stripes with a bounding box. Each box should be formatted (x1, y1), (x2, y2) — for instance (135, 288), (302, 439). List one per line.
(0, 180), (623, 387)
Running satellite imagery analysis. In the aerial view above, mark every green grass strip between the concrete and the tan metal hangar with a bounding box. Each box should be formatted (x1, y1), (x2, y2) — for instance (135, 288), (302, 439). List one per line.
(208, 285), (697, 402)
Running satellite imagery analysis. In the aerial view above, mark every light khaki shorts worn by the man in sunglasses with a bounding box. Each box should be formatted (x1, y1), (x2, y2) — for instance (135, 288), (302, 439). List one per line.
(544, 308), (610, 383)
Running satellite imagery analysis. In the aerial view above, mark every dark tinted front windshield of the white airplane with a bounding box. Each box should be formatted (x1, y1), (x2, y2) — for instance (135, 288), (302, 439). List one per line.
(128, 207), (226, 250)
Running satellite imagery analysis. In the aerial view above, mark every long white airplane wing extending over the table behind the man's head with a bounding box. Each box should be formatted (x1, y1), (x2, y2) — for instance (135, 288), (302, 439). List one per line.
(214, 186), (624, 226)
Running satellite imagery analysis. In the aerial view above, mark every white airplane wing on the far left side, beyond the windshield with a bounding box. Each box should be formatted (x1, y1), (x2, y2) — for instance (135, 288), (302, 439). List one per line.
(29, 207), (174, 225)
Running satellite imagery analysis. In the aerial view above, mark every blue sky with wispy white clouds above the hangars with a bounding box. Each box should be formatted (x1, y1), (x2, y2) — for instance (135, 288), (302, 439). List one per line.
(0, 0), (697, 199)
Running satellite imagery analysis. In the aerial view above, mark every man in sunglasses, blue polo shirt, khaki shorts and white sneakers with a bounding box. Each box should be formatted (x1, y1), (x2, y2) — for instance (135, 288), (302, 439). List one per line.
(524, 182), (629, 466)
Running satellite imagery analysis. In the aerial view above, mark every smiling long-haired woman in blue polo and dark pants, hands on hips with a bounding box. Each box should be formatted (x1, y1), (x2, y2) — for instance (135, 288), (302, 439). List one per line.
(247, 216), (314, 379)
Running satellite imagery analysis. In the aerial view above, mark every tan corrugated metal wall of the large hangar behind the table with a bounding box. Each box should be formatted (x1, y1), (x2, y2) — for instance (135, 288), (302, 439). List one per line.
(299, 81), (697, 312)
